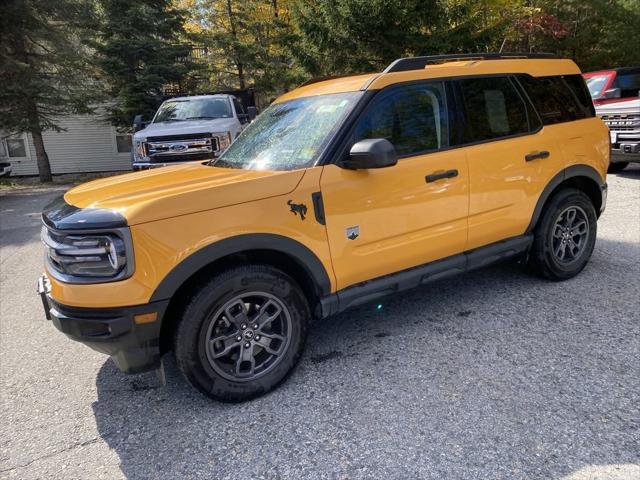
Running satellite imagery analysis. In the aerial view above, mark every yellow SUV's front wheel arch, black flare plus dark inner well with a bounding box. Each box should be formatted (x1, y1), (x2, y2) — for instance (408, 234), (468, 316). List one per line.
(150, 233), (331, 352)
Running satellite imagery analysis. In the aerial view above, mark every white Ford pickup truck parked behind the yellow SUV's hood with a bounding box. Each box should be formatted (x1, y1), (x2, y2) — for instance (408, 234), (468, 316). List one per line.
(132, 94), (256, 170)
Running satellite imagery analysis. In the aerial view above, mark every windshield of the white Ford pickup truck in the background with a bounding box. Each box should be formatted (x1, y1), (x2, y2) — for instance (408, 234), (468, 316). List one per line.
(153, 97), (233, 123)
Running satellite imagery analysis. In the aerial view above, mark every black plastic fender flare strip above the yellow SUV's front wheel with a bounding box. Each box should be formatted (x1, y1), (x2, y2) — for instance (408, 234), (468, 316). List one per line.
(149, 233), (331, 302)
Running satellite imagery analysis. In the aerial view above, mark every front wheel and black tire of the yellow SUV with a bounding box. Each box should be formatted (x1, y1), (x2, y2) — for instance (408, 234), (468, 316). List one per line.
(174, 265), (311, 402)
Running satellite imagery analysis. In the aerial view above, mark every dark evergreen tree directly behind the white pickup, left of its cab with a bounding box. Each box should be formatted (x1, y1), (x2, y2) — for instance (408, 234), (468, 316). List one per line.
(92, 0), (191, 127)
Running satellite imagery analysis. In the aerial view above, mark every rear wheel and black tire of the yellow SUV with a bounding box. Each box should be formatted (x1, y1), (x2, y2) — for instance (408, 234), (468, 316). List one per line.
(529, 188), (597, 280)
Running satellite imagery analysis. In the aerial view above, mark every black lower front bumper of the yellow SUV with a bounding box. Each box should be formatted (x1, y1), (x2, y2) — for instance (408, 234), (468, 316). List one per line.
(38, 275), (169, 373)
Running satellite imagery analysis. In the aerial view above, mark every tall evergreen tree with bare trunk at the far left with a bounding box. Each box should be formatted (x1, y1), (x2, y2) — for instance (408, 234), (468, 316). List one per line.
(0, 0), (94, 182)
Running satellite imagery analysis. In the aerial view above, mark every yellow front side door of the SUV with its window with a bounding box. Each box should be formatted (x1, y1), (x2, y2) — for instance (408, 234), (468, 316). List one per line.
(320, 82), (469, 289)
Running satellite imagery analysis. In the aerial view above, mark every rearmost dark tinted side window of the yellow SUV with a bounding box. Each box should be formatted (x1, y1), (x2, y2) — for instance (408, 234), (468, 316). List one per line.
(519, 75), (595, 125)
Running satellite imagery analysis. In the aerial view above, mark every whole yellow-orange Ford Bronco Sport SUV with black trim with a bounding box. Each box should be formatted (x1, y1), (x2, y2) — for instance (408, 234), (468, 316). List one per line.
(39, 54), (610, 401)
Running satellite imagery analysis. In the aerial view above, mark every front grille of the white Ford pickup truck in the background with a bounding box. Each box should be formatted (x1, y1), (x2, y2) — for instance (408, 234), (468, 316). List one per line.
(144, 133), (218, 163)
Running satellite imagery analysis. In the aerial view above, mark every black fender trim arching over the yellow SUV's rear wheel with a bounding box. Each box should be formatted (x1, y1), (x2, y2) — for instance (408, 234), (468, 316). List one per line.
(526, 165), (606, 233)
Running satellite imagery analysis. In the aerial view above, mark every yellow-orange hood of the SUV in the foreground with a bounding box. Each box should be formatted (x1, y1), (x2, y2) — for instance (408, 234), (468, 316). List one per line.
(64, 162), (304, 225)
